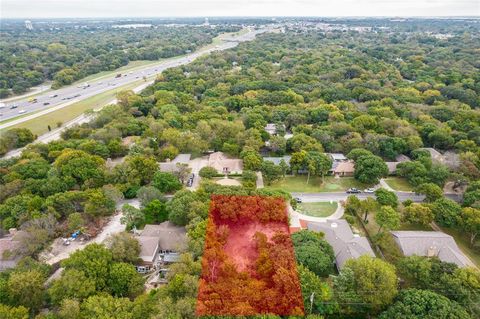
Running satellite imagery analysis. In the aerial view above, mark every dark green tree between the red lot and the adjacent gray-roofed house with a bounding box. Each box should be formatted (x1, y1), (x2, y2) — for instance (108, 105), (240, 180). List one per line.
(292, 230), (335, 277)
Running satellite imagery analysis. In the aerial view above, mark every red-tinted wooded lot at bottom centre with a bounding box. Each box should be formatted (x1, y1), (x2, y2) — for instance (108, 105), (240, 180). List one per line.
(196, 195), (304, 316)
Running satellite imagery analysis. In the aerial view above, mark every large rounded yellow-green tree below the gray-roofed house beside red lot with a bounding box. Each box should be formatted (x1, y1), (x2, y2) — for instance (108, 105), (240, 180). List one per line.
(334, 255), (398, 313)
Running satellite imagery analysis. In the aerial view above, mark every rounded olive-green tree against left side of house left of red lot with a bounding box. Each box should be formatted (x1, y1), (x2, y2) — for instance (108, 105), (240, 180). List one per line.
(106, 232), (140, 264)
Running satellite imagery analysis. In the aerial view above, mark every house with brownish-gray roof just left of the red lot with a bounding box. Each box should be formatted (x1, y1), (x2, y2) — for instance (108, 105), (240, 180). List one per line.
(137, 221), (187, 273)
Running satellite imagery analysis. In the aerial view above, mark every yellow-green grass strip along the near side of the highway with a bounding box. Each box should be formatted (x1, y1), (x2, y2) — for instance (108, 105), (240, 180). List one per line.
(0, 80), (143, 135)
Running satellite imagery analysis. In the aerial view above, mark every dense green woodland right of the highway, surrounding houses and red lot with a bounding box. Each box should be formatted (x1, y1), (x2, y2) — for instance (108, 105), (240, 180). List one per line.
(0, 19), (480, 319)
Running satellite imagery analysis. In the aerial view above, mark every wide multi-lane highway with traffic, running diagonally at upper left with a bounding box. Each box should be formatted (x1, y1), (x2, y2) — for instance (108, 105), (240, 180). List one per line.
(0, 29), (268, 129)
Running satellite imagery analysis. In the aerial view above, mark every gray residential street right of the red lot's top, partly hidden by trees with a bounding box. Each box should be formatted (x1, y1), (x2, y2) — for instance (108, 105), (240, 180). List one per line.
(292, 192), (461, 202)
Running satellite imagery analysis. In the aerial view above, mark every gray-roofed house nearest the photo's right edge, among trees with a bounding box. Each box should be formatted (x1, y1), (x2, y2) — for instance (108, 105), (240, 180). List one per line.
(391, 231), (472, 267)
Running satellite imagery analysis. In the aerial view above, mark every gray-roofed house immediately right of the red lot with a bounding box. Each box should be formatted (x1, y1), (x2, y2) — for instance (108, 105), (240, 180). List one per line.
(307, 219), (375, 270)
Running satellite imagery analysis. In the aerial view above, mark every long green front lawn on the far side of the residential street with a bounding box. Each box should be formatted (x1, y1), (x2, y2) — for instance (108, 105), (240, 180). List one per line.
(267, 175), (367, 193)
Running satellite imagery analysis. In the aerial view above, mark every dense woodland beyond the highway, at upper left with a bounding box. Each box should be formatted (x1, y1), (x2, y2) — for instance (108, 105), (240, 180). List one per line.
(0, 24), (238, 98)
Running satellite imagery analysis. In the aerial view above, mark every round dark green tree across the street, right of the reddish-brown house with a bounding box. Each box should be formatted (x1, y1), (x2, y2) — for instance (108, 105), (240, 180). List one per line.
(354, 156), (388, 184)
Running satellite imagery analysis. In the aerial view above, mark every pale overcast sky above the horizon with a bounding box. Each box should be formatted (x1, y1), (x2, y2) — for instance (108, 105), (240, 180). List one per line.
(0, 0), (480, 18)
